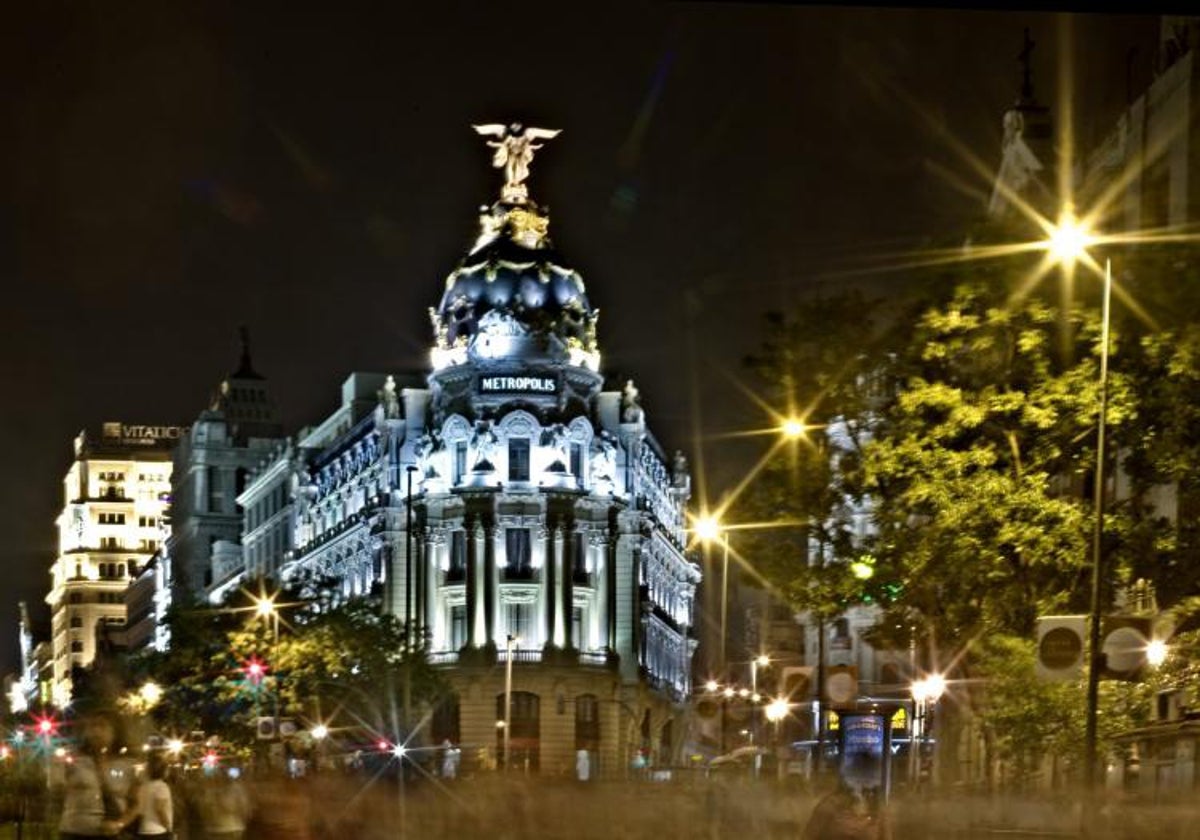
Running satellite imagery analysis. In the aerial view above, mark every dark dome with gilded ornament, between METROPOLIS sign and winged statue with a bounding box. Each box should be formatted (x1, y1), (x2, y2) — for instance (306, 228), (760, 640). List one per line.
(430, 202), (598, 367)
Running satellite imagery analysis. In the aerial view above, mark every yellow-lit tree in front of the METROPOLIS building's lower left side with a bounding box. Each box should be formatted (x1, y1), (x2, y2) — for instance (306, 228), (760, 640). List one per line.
(138, 593), (446, 744)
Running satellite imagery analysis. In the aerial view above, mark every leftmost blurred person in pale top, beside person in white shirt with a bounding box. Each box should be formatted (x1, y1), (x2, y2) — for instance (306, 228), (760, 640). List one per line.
(59, 712), (136, 840)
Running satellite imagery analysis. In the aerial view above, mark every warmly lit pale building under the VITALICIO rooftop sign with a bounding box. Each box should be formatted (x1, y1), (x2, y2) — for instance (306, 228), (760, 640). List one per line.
(46, 422), (176, 706)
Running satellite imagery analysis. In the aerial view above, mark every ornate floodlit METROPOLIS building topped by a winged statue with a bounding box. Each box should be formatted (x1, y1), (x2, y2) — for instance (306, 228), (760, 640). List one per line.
(231, 126), (700, 775)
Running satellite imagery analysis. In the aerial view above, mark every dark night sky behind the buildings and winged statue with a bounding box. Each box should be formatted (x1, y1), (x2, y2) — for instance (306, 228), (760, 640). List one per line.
(0, 0), (1158, 673)
